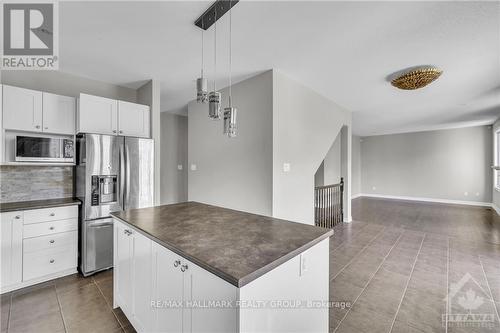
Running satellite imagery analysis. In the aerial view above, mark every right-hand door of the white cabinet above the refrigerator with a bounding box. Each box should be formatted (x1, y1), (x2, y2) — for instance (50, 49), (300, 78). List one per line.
(118, 101), (150, 138)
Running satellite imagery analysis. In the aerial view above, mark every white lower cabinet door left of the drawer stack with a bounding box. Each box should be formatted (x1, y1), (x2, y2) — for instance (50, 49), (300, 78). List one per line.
(0, 212), (23, 292)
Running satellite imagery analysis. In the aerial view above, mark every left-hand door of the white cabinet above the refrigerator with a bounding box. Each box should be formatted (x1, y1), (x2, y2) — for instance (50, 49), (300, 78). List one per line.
(77, 94), (118, 135)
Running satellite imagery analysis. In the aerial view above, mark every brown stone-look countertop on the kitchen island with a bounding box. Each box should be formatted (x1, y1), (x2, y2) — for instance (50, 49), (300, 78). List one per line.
(111, 202), (333, 287)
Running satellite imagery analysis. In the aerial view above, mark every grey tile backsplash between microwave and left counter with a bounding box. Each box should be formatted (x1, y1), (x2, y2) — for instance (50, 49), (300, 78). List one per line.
(0, 165), (73, 203)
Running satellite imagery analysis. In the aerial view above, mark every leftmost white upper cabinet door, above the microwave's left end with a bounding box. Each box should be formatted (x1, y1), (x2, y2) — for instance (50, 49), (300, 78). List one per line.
(3, 85), (43, 132)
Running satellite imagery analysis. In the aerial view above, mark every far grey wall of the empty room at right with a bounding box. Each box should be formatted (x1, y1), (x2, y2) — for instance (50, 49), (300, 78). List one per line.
(361, 126), (493, 203)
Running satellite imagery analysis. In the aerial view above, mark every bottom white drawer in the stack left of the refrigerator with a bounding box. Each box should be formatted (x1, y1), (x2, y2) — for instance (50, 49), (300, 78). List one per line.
(23, 244), (76, 281)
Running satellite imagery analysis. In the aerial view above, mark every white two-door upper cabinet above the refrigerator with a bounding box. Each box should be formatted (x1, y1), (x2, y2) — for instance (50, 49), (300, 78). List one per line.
(77, 94), (150, 138)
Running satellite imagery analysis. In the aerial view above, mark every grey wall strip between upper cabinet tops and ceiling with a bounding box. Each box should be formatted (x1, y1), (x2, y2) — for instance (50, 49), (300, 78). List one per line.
(1, 71), (137, 102)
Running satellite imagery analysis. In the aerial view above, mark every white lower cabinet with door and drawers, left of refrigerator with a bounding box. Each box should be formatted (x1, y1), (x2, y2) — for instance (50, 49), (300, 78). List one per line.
(0, 205), (78, 293)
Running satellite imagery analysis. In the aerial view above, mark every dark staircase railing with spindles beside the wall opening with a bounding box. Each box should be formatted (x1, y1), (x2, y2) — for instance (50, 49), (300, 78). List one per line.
(314, 178), (344, 228)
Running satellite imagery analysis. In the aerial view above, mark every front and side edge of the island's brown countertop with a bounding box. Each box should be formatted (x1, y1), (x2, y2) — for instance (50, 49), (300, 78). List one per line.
(110, 213), (333, 288)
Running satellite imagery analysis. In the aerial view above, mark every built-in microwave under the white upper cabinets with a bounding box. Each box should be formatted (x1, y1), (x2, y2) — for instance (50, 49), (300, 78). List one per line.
(15, 135), (75, 163)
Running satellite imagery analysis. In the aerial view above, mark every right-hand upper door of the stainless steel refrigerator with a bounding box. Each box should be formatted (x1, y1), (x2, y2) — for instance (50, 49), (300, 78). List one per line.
(123, 137), (154, 209)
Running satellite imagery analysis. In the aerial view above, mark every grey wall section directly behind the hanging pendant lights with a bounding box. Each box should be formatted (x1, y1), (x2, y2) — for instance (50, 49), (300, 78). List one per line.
(188, 71), (274, 216)
